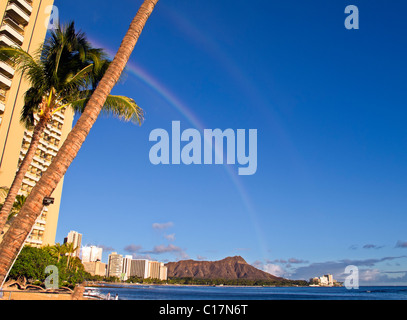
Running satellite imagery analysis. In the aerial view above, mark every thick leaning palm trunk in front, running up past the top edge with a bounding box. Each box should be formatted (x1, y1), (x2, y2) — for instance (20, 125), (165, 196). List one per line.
(0, 0), (158, 287)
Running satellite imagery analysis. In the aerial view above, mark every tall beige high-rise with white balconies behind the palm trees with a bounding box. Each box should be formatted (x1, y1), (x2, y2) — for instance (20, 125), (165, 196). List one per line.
(0, 0), (73, 246)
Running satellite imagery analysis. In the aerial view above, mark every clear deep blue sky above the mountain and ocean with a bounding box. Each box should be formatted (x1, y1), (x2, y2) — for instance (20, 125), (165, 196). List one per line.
(51, 0), (407, 284)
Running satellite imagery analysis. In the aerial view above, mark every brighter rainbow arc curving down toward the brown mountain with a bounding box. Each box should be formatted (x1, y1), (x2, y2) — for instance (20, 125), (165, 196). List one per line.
(90, 39), (267, 259)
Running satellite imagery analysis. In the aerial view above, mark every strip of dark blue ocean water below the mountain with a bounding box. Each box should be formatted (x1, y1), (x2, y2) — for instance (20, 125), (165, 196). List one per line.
(87, 285), (407, 300)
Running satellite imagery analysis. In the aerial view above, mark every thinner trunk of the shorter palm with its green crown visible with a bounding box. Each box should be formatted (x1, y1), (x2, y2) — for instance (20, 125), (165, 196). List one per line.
(0, 118), (48, 232)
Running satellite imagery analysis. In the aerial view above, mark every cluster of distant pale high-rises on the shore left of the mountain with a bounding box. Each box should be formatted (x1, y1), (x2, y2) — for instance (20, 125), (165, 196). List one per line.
(64, 231), (167, 281)
